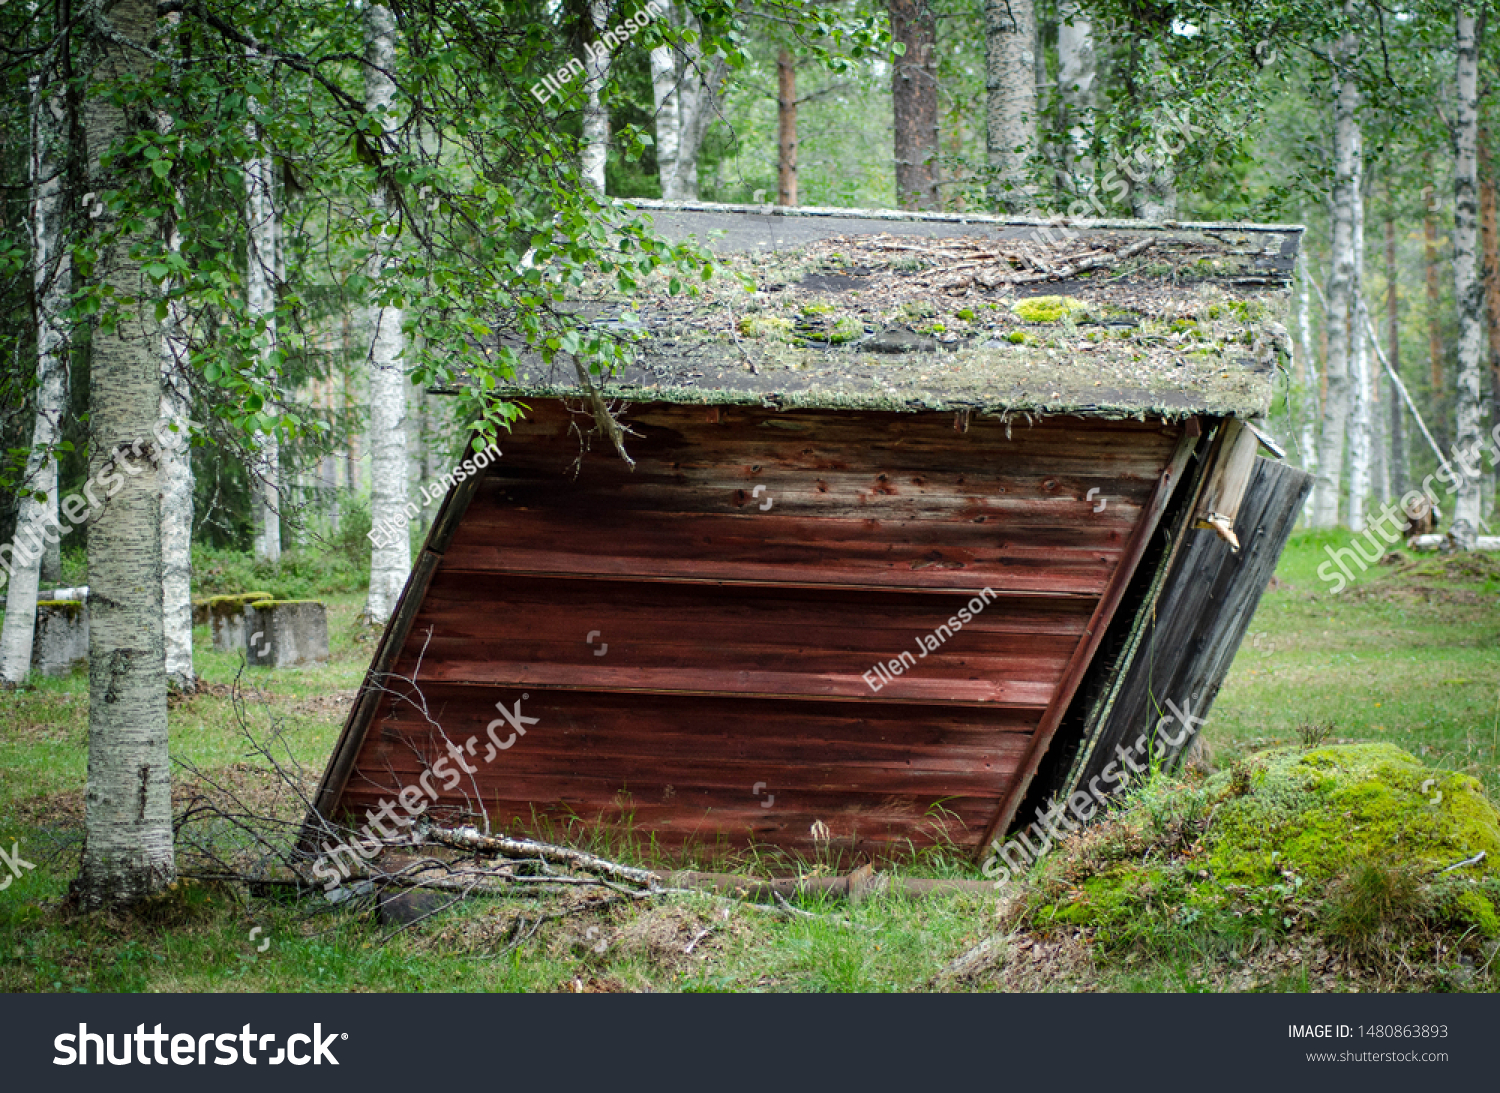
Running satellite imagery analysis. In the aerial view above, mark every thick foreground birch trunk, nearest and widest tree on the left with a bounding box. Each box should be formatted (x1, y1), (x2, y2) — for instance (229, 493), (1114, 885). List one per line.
(74, 0), (176, 907)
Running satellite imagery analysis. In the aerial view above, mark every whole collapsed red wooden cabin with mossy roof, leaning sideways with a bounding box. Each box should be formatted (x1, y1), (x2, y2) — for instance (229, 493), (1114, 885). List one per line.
(315, 201), (1310, 856)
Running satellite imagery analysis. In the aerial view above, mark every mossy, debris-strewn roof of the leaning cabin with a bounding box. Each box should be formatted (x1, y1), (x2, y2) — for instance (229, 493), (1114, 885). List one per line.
(483, 199), (1302, 418)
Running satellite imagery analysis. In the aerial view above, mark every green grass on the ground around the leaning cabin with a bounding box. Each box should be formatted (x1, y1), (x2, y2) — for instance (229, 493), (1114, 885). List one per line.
(0, 535), (1500, 991)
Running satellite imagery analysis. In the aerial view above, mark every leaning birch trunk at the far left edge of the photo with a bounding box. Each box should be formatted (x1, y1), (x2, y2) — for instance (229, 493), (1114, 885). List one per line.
(0, 55), (72, 684)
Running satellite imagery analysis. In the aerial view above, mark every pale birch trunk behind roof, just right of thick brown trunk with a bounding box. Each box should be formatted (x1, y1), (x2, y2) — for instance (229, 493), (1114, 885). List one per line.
(984, 0), (1037, 213)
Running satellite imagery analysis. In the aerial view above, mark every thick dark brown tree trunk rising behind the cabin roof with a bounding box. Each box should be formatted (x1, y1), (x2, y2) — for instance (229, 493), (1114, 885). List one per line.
(888, 0), (941, 210)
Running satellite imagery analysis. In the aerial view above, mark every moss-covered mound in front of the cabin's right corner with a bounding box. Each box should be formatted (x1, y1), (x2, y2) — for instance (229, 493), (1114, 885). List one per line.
(1017, 744), (1500, 955)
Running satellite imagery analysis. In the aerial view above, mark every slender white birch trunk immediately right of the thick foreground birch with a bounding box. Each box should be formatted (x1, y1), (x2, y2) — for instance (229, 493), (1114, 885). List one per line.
(156, 12), (197, 691)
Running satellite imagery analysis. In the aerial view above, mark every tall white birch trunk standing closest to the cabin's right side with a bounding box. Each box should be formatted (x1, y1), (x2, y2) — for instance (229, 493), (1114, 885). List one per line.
(1313, 23), (1362, 528)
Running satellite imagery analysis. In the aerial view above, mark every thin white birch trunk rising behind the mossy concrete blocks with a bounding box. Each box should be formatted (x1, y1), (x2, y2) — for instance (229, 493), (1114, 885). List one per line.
(245, 70), (281, 562)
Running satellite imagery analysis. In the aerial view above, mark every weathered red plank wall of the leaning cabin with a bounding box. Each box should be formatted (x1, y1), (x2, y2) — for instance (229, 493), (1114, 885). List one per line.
(320, 402), (1185, 855)
